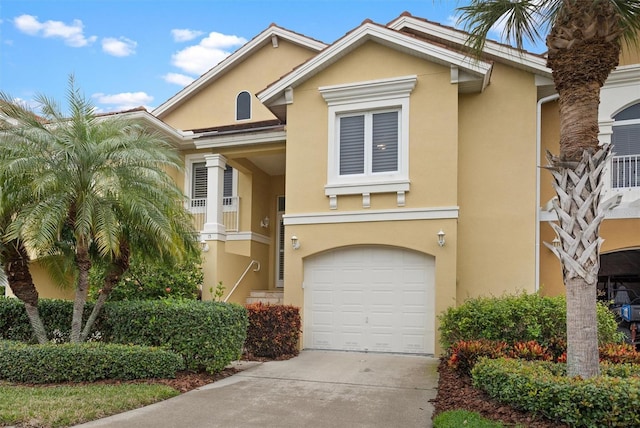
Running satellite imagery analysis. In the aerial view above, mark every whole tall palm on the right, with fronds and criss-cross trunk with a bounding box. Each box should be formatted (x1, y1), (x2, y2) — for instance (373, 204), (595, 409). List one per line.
(458, 0), (640, 378)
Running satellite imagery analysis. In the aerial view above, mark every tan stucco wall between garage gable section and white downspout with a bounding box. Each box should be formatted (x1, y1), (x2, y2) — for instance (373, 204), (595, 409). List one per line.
(457, 63), (537, 303)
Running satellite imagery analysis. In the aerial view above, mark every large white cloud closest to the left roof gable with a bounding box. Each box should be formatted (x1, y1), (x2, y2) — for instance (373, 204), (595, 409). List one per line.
(172, 32), (247, 75)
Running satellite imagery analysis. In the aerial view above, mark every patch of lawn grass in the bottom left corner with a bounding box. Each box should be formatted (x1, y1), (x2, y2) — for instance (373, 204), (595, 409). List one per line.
(0, 382), (180, 428)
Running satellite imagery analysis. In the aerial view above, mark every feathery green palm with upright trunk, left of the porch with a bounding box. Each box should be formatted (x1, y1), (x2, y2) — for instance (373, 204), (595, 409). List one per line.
(0, 77), (196, 342)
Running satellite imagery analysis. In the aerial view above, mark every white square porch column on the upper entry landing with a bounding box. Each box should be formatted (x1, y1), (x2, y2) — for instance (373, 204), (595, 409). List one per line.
(203, 154), (227, 241)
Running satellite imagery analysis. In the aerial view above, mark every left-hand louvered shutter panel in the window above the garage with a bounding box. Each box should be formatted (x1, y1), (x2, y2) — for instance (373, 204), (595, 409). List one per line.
(340, 116), (364, 175)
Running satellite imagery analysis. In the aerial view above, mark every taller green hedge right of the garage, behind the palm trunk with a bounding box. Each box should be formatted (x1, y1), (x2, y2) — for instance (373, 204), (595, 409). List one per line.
(439, 293), (622, 349)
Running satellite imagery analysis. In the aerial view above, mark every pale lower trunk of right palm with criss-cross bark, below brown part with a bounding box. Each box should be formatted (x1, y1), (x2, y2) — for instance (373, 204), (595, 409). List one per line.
(545, 145), (611, 379)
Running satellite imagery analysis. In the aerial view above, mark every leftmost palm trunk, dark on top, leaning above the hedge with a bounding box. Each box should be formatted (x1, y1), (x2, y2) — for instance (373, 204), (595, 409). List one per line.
(4, 243), (47, 344)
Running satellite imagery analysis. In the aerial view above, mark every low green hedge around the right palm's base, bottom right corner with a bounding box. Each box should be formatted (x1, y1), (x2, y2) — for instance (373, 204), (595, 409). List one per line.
(471, 358), (640, 427)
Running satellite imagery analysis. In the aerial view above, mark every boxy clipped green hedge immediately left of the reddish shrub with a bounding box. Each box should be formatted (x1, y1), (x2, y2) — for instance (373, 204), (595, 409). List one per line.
(103, 299), (248, 373)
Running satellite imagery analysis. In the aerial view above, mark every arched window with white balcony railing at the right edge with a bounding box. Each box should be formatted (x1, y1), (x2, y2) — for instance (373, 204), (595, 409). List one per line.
(611, 103), (640, 188)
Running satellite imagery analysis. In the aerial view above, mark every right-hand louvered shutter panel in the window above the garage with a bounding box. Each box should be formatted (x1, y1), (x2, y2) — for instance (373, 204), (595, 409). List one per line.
(371, 111), (398, 172)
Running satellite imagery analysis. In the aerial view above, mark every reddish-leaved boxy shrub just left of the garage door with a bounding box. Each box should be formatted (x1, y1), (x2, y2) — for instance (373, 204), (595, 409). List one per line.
(244, 303), (300, 358)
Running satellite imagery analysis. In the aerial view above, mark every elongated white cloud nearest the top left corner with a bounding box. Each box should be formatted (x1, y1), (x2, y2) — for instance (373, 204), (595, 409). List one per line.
(13, 15), (97, 48)
